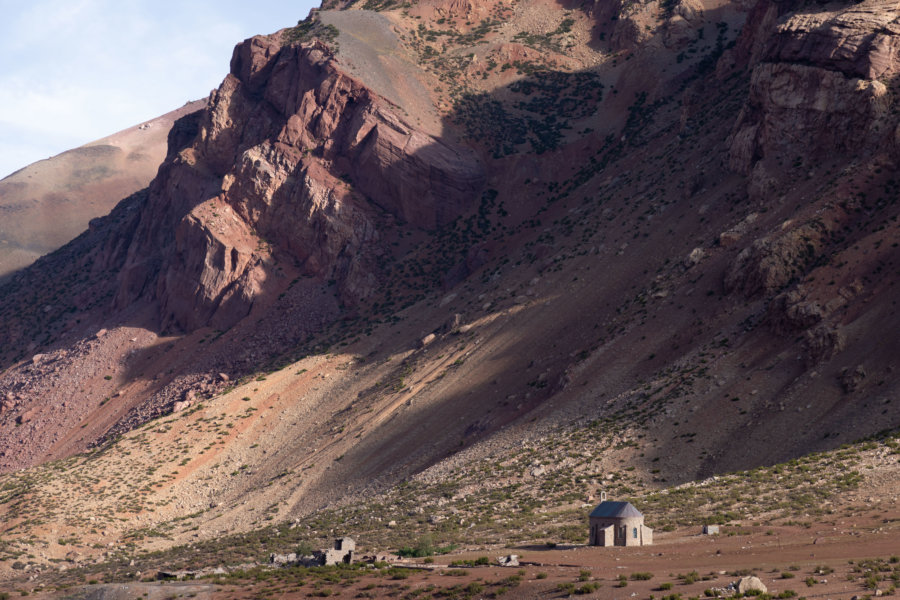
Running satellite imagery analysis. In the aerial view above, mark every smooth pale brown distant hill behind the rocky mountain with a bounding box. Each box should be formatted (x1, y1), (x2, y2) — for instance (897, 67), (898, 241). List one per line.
(0, 101), (205, 277)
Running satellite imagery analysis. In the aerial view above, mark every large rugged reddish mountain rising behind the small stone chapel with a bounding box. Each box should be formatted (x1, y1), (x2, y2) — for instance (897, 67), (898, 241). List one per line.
(0, 0), (900, 592)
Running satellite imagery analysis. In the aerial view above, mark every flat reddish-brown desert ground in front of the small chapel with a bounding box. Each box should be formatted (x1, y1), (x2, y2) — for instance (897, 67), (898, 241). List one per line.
(19, 508), (900, 600)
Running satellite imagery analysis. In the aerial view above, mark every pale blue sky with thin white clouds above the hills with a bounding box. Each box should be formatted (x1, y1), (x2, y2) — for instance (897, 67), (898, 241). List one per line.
(0, 0), (320, 179)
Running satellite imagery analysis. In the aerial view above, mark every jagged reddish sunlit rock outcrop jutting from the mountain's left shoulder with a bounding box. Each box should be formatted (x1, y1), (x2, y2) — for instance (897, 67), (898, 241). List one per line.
(116, 34), (484, 330)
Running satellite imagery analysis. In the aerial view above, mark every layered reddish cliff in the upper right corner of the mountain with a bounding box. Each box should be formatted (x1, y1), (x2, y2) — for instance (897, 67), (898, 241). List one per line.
(730, 0), (900, 177)
